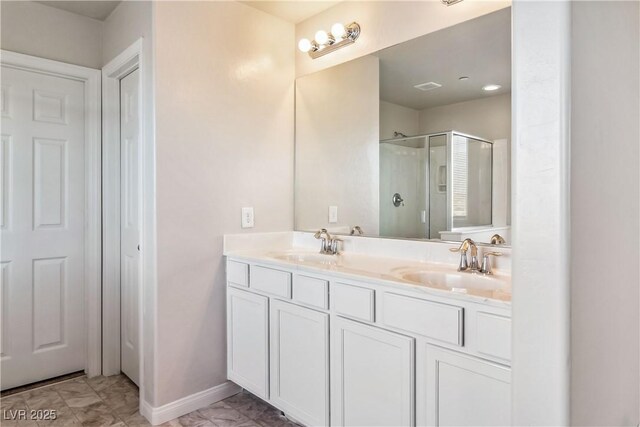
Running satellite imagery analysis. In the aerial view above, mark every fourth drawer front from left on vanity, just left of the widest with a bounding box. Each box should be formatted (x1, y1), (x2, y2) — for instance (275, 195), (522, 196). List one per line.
(329, 283), (375, 322)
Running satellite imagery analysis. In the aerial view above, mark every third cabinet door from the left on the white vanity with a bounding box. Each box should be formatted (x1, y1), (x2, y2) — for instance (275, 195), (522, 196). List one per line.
(331, 317), (414, 426)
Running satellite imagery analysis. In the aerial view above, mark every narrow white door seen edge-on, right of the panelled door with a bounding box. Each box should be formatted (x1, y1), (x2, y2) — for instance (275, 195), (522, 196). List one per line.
(120, 70), (141, 384)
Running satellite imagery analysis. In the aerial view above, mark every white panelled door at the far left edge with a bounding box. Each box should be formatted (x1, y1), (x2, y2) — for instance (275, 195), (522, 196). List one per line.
(0, 66), (86, 390)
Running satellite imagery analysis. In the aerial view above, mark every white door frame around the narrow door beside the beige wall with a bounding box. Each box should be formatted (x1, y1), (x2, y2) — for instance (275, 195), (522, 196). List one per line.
(102, 38), (148, 388)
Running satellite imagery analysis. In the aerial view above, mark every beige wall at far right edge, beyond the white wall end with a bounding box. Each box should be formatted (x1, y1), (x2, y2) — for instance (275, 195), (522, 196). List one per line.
(571, 1), (640, 426)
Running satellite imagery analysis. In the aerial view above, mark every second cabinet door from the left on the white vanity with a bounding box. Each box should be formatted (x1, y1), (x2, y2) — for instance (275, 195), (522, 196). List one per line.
(270, 300), (329, 426)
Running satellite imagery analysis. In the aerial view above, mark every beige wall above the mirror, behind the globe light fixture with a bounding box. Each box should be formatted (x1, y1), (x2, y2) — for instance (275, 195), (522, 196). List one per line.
(296, 0), (511, 76)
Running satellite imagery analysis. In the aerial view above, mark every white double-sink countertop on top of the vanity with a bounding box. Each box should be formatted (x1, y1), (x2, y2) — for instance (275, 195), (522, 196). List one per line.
(225, 247), (511, 308)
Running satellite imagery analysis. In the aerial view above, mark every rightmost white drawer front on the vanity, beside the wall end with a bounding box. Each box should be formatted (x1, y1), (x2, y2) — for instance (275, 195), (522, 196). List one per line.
(476, 311), (511, 360)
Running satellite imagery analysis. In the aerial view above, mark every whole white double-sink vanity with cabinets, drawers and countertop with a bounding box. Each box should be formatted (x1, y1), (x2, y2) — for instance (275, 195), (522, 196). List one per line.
(226, 236), (511, 426)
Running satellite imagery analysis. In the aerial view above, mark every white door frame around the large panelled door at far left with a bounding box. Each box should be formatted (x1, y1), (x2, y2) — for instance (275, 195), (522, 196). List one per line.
(0, 50), (102, 377)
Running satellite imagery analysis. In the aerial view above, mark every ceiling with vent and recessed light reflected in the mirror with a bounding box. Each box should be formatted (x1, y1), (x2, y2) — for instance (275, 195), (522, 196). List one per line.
(374, 8), (511, 110)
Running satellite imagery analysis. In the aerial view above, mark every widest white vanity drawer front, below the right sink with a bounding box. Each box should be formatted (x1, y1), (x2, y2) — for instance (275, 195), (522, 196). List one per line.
(380, 292), (464, 346)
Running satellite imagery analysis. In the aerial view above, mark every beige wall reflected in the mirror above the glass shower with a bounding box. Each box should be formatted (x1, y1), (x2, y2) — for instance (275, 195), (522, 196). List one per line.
(420, 93), (511, 140)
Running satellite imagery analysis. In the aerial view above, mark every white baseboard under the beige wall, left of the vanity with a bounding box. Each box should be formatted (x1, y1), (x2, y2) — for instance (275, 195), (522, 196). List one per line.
(140, 381), (242, 426)
